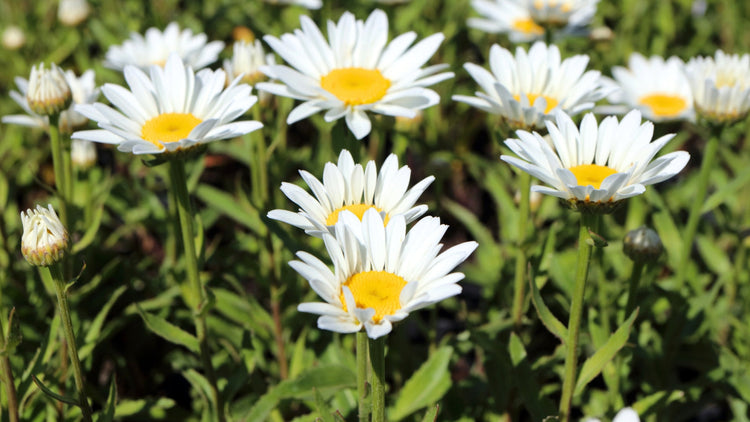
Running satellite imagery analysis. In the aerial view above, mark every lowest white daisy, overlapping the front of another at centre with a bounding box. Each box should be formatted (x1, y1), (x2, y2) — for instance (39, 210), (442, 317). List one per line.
(289, 210), (477, 338)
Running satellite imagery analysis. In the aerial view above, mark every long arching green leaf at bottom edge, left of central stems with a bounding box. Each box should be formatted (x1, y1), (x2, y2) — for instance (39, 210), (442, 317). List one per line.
(244, 365), (356, 421)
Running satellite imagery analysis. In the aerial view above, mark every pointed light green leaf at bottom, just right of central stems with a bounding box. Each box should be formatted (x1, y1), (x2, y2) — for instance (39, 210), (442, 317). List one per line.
(389, 346), (453, 421)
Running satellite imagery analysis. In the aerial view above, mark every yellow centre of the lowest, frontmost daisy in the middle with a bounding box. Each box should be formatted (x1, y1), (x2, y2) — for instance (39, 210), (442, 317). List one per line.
(339, 271), (406, 323)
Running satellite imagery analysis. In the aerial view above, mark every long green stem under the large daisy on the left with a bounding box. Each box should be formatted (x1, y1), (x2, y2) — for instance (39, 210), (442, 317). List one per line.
(164, 159), (225, 422)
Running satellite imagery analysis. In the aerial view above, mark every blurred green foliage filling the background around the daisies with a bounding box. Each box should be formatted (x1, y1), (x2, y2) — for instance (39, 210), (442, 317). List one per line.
(0, 0), (750, 421)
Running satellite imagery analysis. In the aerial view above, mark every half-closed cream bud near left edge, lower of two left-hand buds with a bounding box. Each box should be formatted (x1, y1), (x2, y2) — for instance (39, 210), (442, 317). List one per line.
(21, 205), (68, 267)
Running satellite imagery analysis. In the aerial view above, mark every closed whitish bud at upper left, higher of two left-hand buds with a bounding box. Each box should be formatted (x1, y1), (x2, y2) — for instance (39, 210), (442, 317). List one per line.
(26, 63), (73, 116)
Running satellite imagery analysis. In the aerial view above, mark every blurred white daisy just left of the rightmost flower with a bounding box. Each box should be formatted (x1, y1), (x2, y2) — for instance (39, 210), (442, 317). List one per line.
(609, 53), (693, 121)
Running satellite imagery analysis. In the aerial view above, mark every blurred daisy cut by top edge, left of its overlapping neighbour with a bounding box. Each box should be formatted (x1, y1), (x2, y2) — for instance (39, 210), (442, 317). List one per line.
(467, 0), (544, 43)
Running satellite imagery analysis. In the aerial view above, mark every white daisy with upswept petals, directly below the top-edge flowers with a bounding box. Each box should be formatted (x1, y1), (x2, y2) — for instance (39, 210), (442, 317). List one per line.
(453, 41), (610, 129)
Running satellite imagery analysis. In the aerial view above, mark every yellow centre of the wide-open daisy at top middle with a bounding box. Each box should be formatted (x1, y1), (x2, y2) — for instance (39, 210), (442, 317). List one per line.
(320, 67), (391, 106)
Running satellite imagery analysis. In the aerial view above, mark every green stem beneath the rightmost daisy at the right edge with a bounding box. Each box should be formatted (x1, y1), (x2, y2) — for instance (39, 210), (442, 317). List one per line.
(676, 134), (719, 289)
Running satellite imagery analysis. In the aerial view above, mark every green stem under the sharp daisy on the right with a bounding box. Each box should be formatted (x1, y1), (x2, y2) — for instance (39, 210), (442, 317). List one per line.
(560, 212), (599, 422)
